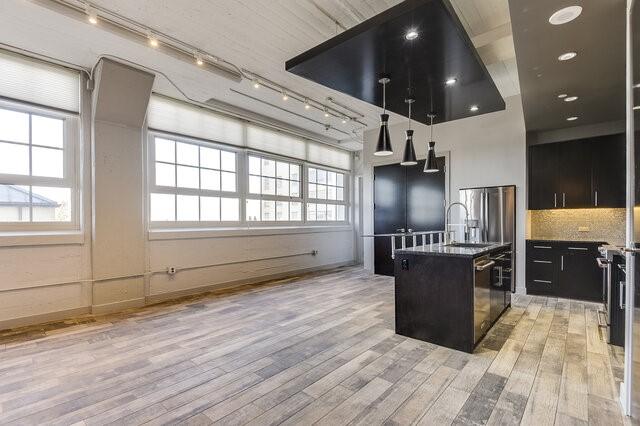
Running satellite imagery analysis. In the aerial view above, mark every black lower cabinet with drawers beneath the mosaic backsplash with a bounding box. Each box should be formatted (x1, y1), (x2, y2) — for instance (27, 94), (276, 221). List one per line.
(526, 240), (604, 302)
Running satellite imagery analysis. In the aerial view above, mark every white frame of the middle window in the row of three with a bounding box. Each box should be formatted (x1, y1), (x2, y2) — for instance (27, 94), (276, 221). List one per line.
(243, 150), (306, 227)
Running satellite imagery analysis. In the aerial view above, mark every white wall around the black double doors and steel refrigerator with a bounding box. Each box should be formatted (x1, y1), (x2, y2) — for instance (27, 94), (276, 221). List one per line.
(363, 96), (526, 292)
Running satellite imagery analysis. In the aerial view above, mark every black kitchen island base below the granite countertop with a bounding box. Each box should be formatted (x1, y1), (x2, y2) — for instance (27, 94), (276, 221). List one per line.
(395, 245), (511, 353)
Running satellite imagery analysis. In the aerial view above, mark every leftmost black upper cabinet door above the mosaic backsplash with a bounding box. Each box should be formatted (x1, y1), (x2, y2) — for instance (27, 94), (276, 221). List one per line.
(529, 144), (558, 210)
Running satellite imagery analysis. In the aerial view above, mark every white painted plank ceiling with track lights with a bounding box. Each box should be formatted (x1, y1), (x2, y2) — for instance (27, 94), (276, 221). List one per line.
(0, 0), (520, 150)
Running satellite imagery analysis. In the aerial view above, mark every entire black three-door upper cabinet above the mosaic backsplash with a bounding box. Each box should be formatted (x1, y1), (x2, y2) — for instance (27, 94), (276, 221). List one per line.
(529, 134), (626, 210)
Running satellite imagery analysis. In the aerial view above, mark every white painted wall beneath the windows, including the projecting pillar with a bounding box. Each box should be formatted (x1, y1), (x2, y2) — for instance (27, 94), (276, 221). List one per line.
(0, 60), (356, 329)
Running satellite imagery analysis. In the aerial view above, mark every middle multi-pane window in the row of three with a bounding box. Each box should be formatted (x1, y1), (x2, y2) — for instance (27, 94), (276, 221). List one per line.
(246, 154), (303, 222)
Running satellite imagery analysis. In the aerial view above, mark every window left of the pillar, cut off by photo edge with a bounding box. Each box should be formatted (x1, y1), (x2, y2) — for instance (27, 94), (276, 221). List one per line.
(0, 102), (79, 230)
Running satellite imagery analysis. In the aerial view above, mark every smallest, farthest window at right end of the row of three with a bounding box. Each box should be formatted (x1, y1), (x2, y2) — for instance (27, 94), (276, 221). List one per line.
(307, 167), (347, 222)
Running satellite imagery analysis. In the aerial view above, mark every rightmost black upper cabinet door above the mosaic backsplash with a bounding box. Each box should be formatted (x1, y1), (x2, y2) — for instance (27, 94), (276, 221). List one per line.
(589, 134), (626, 208)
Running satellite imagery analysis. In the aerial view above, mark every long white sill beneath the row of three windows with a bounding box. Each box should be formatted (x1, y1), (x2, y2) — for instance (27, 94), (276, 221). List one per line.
(149, 225), (353, 241)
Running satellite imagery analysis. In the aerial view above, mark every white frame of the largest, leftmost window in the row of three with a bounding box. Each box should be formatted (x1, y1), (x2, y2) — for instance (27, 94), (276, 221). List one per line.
(147, 130), (244, 230)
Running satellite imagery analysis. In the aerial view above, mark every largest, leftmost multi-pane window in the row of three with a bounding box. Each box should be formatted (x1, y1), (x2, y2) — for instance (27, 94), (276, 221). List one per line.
(149, 135), (240, 222)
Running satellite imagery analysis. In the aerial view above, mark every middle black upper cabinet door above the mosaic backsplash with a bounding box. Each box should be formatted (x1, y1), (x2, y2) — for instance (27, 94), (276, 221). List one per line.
(556, 140), (592, 209)
